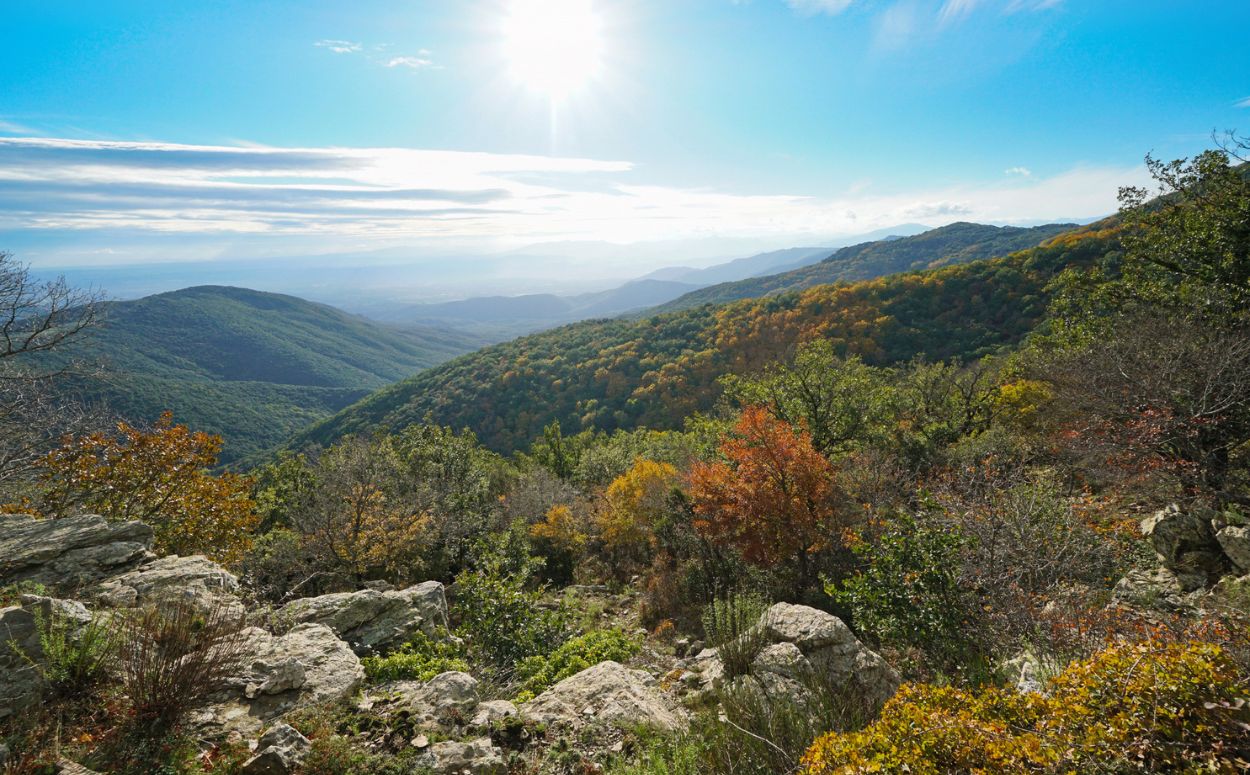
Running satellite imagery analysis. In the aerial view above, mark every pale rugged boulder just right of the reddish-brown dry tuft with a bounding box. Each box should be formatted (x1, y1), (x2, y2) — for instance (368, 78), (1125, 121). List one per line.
(193, 624), (365, 738)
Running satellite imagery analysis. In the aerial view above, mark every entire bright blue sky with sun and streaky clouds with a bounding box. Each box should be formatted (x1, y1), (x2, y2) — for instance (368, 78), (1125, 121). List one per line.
(0, 0), (1250, 274)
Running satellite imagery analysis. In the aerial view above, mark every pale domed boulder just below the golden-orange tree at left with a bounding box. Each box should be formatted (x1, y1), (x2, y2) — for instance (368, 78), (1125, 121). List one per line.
(93, 555), (245, 616)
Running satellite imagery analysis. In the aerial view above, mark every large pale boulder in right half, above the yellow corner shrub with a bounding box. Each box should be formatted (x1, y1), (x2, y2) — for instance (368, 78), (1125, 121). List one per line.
(751, 603), (903, 710)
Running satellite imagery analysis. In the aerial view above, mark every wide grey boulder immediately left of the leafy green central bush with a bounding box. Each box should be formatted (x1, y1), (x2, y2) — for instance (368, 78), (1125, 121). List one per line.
(279, 581), (448, 656)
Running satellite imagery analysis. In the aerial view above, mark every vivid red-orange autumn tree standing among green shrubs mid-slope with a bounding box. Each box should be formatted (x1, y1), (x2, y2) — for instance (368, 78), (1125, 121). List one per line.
(690, 406), (843, 580)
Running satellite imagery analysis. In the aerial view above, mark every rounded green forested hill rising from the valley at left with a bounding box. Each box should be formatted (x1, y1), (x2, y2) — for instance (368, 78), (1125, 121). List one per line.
(60, 286), (481, 463)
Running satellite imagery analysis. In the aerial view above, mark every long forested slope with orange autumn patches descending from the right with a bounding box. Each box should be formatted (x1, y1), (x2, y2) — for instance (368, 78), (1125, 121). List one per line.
(291, 223), (1118, 451)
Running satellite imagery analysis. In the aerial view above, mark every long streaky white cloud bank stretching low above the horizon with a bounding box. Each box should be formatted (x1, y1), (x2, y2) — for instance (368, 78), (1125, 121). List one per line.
(0, 138), (1149, 260)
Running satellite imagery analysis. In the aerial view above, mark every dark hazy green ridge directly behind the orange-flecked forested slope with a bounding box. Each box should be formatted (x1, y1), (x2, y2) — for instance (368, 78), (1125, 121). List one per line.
(649, 223), (1075, 313)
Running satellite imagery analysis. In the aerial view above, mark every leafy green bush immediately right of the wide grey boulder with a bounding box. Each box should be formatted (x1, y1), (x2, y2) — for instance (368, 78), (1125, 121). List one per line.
(453, 531), (569, 670)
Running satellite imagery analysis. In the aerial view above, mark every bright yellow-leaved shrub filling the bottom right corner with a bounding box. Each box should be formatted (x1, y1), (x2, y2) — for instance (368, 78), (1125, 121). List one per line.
(804, 641), (1250, 775)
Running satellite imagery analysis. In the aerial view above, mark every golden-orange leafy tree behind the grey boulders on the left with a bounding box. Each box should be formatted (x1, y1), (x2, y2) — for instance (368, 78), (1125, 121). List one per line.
(33, 413), (258, 564)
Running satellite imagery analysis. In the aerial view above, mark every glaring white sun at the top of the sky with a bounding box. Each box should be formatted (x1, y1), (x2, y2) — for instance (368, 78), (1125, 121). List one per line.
(504, 0), (604, 103)
